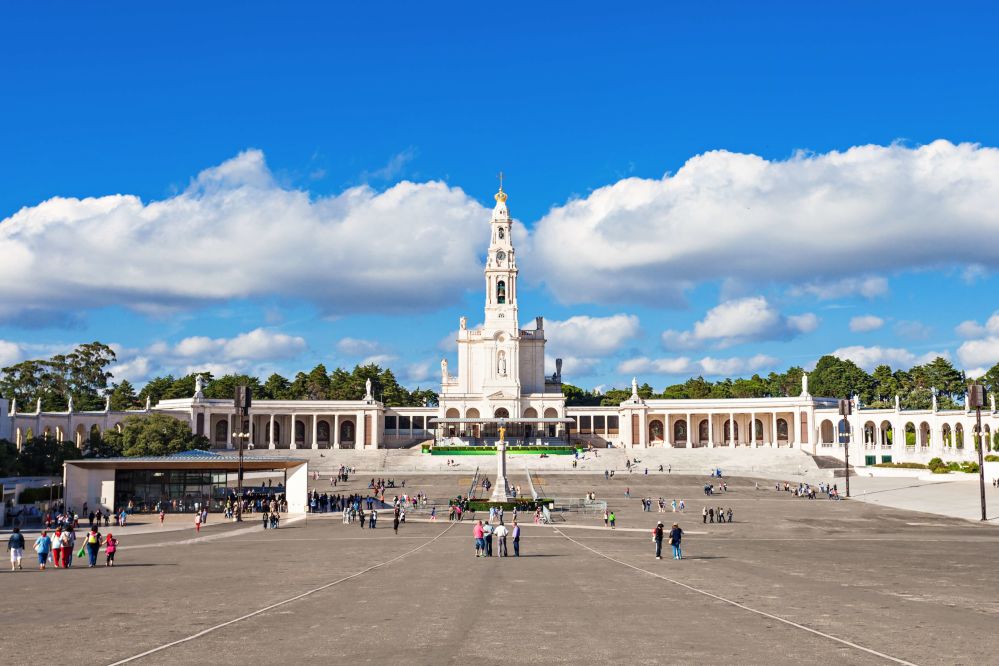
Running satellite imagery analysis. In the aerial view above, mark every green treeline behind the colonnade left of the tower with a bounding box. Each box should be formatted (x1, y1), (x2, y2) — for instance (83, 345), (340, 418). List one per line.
(0, 342), (437, 412)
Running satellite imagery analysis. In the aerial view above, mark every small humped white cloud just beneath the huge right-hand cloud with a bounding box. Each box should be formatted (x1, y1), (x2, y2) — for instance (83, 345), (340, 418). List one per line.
(662, 296), (819, 349)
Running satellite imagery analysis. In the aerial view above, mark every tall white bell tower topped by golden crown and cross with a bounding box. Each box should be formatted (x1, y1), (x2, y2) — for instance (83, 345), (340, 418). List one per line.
(483, 173), (520, 337)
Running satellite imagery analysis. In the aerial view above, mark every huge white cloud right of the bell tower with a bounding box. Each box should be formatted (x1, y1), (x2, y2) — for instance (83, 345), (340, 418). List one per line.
(532, 140), (999, 304)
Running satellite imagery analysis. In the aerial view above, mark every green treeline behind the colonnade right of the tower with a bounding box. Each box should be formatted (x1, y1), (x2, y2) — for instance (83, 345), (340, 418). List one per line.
(562, 356), (999, 409)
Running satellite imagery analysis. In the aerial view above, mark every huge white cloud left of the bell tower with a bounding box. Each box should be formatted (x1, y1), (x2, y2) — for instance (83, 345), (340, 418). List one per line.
(0, 150), (489, 319)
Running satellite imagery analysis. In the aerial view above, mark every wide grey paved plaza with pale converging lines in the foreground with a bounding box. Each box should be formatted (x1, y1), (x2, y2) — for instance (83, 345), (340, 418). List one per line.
(0, 475), (999, 664)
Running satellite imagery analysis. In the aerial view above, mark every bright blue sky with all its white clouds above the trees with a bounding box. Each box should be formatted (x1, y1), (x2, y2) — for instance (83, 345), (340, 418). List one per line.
(0, 2), (999, 388)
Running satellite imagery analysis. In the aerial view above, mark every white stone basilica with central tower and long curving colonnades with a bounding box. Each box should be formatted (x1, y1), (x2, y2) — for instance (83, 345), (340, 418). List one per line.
(0, 186), (999, 466)
